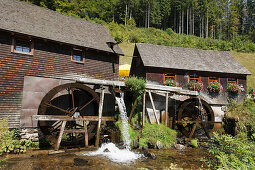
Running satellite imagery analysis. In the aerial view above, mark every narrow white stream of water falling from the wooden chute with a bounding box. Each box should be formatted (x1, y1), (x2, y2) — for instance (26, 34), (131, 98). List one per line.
(115, 93), (131, 150)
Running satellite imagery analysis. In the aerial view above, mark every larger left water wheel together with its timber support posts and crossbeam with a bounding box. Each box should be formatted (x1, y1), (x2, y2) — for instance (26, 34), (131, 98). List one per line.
(34, 83), (113, 150)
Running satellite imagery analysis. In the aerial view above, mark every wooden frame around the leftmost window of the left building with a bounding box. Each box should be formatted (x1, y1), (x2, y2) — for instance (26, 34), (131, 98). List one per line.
(11, 35), (34, 55)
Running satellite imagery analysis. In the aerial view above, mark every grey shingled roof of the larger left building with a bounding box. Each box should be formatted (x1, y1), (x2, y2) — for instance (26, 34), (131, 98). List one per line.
(0, 0), (123, 55)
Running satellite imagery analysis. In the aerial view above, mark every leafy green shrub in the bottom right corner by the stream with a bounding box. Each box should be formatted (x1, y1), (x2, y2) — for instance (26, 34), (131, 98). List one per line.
(207, 133), (255, 169)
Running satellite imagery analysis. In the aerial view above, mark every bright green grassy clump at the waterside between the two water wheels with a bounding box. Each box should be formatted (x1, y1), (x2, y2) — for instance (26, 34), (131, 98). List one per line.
(139, 123), (176, 148)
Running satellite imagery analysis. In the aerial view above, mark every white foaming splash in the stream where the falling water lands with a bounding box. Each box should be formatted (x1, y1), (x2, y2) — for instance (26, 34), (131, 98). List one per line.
(84, 143), (142, 163)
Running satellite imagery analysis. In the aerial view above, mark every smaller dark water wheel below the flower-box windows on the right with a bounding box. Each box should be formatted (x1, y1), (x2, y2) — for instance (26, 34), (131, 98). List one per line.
(177, 98), (214, 139)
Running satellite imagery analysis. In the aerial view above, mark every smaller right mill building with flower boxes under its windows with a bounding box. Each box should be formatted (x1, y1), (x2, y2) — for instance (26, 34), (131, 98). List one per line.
(130, 43), (251, 131)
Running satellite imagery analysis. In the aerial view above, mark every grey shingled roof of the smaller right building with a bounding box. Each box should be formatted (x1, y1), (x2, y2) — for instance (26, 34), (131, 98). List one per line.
(136, 44), (251, 75)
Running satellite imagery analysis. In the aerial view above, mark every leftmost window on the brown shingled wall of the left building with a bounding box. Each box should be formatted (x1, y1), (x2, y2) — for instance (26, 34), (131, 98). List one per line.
(11, 37), (34, 55)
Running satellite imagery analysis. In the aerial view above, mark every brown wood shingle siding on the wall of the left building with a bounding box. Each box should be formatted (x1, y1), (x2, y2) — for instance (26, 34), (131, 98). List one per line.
(0, 31), (119, 127)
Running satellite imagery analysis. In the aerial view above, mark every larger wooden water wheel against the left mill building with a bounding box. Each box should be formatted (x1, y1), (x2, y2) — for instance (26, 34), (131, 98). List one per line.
(38, 83), (99, 147)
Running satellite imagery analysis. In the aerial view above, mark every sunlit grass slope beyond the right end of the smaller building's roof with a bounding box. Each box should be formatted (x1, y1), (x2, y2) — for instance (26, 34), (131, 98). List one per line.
(229, 51), (255, 89)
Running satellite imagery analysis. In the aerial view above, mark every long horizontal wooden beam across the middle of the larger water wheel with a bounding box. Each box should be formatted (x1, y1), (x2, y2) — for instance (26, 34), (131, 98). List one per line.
(32, 115), (115, 121)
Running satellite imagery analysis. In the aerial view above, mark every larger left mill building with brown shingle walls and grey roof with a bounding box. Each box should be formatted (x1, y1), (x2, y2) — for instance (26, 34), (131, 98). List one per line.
(0, 0), (123, 133)
